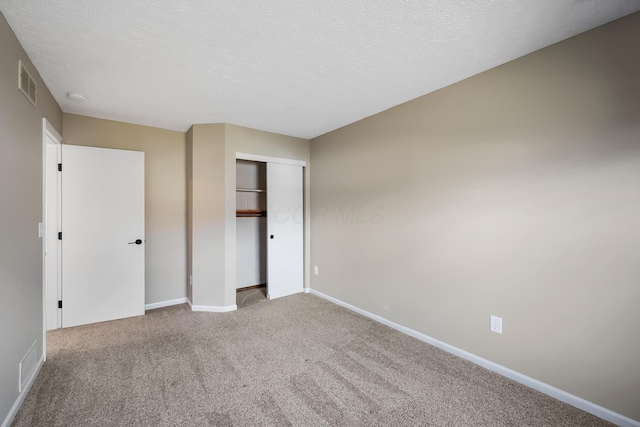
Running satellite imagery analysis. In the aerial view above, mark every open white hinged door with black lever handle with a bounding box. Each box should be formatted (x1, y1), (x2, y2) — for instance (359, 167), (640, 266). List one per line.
(62, 145), (144, 327)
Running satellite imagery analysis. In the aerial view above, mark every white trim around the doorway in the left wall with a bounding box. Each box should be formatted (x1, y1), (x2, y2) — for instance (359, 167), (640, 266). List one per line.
(41, 117), (62, 360)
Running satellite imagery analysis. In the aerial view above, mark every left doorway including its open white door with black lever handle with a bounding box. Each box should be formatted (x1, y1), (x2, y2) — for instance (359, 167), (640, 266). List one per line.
(43, 140), (145, 331)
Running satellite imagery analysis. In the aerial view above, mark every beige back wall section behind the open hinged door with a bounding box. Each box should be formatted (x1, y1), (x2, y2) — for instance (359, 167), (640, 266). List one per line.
(64, 113), (187, 304)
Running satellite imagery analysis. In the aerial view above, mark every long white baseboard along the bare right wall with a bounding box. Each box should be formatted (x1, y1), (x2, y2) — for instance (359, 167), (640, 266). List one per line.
(311, 289), (640, 427)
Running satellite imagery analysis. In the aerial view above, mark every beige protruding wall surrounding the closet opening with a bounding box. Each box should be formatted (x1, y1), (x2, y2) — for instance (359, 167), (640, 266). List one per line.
(187, 124), (309, 309)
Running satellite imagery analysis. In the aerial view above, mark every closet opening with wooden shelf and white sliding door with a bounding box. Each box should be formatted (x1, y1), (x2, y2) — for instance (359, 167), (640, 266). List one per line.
(236, 155), (304, 307)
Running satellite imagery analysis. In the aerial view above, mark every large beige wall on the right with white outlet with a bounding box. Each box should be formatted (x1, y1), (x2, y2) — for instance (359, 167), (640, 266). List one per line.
(311, 13), (640, 420)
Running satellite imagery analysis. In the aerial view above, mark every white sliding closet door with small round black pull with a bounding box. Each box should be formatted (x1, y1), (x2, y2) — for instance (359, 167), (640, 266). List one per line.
(267, 163), (304, 299)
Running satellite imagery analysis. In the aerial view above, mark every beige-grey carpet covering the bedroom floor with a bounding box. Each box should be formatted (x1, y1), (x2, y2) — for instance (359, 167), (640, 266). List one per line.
(13, 294), (610, 427)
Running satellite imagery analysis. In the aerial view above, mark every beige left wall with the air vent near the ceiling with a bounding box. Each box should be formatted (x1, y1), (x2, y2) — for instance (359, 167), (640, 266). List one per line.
(0, 10), (62, 423)
